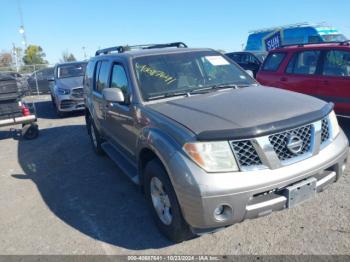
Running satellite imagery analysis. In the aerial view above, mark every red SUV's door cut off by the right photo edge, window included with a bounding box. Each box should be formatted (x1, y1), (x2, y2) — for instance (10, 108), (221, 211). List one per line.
(319, 49), (350, 115)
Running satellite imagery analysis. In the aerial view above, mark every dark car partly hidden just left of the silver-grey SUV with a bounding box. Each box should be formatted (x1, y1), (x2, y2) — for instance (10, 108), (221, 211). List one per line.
(28, 67), (54, 94)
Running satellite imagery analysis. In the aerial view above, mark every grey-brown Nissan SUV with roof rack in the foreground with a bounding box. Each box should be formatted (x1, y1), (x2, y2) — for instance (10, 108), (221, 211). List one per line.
(84, 43), (349, 242)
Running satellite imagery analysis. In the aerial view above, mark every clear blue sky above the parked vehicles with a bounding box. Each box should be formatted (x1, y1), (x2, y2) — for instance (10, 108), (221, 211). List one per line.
(0, 0), (350, 63)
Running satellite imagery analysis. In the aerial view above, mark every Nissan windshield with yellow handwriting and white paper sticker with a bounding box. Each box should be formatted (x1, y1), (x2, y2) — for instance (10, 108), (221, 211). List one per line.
(134, 51), (256, 100)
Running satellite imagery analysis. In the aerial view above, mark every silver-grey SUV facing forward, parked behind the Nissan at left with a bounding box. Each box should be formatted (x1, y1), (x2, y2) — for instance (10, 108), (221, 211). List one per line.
(50, 62), (87, 116)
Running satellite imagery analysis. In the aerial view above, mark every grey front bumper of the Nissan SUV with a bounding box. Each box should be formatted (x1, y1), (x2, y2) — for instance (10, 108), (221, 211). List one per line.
(167, 131), (349, 230)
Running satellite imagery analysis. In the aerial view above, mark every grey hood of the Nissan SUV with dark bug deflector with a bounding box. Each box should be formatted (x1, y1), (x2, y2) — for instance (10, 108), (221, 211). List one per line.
(149, 86), (333, 140)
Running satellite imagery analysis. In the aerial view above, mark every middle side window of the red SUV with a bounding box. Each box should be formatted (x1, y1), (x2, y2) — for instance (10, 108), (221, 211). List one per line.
(286, 50), (320, 75)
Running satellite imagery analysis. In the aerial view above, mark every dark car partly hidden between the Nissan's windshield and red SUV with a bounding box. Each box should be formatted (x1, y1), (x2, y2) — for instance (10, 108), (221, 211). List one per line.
(225, 52), (267, 77)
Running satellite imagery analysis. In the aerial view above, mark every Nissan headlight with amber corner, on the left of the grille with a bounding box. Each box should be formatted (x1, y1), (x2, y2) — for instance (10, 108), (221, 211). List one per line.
(183, 141), (238, 172)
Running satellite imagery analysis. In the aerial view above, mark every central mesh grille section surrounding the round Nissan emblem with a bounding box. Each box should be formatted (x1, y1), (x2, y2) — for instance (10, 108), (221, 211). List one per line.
(269, 125), (311, 161)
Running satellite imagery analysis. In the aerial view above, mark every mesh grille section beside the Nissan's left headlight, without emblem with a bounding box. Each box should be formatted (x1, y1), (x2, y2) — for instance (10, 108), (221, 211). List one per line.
(231, 140), (262, 167)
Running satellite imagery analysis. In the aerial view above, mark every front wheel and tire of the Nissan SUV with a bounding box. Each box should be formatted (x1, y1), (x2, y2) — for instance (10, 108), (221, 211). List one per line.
(144, 159), (195, 243)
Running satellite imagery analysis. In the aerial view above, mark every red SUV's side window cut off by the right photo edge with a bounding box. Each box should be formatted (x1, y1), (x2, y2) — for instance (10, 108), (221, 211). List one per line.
(322, 50), (350, 77)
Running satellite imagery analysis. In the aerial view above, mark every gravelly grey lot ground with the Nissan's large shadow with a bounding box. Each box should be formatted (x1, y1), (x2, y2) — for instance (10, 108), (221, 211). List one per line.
(0, 97), (350, 255)
